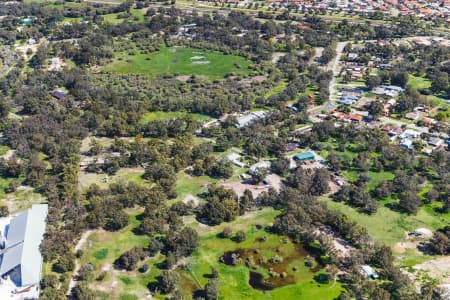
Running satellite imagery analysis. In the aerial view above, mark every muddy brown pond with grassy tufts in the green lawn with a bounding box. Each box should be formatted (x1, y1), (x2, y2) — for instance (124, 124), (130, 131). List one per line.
(220, 244), (321, 291)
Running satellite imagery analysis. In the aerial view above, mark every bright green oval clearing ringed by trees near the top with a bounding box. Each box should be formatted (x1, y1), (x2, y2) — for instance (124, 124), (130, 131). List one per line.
(105, 46), (251, 79)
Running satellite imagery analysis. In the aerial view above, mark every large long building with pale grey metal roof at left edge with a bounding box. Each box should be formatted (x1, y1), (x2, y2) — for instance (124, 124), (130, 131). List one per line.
(0, 204), (48, 292)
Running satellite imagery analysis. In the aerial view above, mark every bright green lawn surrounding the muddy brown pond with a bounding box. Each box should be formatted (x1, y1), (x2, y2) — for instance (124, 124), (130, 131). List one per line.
(182, 209), (342, 299)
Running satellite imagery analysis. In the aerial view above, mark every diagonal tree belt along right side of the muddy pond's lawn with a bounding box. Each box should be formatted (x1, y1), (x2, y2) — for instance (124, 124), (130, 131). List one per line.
(256, 187), (421, 299)
